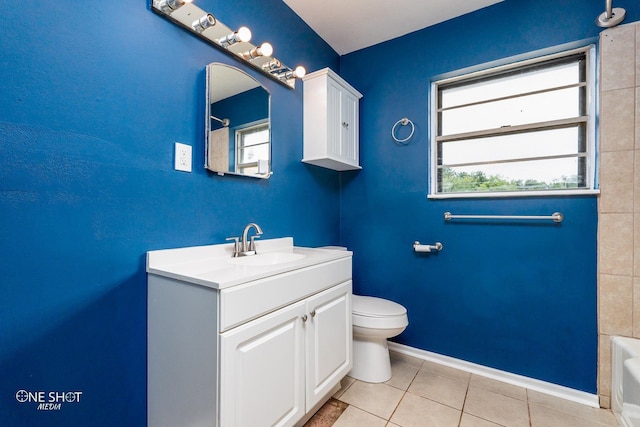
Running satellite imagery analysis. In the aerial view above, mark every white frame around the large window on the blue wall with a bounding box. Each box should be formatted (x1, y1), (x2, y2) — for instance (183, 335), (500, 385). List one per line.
(427, 43), (599, 199)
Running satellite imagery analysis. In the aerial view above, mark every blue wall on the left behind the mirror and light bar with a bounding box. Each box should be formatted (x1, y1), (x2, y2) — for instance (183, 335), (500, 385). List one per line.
(0, 0), (339, 427)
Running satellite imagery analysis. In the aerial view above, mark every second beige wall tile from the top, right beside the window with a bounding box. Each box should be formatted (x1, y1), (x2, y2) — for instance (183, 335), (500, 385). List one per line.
(600, 87), (636, 152)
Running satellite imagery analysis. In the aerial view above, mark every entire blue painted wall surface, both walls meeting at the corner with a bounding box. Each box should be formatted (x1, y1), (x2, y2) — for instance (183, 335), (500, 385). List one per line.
(0, 0), (640, 427)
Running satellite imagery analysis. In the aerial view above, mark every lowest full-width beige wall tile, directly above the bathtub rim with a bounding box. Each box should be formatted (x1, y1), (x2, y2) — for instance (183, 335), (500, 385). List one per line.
(598, 274), (633, 336)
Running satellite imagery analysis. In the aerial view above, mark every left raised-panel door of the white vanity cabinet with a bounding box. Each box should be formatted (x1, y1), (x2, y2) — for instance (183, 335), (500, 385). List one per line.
(219, 301), (305, 427)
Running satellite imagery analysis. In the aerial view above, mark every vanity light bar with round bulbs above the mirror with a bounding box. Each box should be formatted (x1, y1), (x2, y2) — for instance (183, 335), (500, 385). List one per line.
(149, 0), (305, 89)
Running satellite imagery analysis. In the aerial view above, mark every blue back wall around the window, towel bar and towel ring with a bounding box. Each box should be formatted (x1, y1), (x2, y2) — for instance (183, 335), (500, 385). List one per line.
(340, 0), (640, 393)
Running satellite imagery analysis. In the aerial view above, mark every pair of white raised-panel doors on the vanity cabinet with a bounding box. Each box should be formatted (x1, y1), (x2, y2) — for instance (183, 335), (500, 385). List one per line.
(220, 281), (351, 427)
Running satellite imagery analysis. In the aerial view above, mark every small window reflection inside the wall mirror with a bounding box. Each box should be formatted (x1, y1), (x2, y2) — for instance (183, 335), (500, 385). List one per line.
(235, 123), (270, 174)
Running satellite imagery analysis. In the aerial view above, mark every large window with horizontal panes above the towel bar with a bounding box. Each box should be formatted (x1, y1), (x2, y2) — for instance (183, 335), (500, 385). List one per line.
(430, 46), (595, 197)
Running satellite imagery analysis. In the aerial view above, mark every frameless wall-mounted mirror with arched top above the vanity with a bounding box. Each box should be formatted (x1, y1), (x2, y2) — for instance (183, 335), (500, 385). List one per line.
(205, 62), (271, 178)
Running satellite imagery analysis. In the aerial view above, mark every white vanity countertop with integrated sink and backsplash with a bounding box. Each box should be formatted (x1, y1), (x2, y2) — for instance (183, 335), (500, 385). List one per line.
(147, 237), (352, 289)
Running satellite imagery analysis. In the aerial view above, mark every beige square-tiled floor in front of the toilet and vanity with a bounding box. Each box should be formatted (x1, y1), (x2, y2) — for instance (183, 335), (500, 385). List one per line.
(305, 353), (618, 427)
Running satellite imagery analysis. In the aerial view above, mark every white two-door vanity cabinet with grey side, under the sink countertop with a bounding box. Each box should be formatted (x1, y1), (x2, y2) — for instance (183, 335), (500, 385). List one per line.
(147, 239), (352, 427)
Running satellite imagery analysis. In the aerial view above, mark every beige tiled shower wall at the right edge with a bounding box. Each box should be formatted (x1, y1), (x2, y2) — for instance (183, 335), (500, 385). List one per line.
(598, 23), (640, 408)
